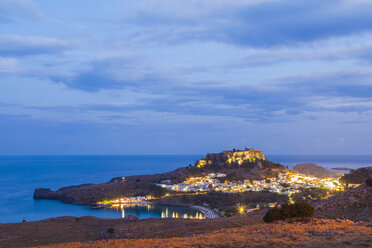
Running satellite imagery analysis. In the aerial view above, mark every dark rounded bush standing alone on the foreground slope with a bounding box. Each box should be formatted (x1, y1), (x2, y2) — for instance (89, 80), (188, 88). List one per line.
(263, 202), (315, 223)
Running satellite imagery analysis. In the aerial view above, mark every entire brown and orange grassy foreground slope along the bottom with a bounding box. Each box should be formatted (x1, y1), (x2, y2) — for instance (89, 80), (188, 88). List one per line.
(0, 212), (372, 248)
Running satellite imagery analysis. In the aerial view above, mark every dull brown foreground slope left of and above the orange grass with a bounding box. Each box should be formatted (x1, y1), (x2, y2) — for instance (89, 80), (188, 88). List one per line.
(0, 216), (263, 248)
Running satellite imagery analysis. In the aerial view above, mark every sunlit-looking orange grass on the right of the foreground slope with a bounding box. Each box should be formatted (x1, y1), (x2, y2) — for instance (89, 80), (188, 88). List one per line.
(35, 220), (372, 248)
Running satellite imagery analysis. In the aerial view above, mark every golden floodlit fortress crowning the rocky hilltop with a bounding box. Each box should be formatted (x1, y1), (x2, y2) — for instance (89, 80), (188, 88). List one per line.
(195, 148), (266, 168)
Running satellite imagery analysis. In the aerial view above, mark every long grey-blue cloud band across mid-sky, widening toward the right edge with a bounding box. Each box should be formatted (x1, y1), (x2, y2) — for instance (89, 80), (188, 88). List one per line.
(21, 68), (372, 123)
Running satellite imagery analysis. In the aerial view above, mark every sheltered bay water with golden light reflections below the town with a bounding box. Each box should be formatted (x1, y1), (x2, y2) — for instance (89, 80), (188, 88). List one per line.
(111, 204), (206, 219)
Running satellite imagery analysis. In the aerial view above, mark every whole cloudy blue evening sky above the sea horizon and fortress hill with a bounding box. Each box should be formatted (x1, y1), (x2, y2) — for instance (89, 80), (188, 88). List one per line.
(0, 0), (372, 155)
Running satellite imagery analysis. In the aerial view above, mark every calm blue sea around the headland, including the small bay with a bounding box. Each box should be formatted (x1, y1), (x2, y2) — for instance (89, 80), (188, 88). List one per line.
(0, 154), (372, 223)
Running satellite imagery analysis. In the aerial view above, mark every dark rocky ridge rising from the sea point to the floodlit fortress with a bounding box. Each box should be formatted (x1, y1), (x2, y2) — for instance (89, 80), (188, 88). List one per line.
(34, 149), (284, 205)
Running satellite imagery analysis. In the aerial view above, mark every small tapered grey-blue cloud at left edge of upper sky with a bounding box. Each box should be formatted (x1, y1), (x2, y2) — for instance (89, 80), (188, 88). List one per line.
(0, 34), (73, 56)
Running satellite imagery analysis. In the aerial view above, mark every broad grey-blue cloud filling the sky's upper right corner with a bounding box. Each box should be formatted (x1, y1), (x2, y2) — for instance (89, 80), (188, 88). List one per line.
(121, 0), (372, 47)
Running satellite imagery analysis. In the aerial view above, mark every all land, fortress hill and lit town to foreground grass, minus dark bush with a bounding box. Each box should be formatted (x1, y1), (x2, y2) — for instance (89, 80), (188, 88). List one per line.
(0, 149), (364, 247)
